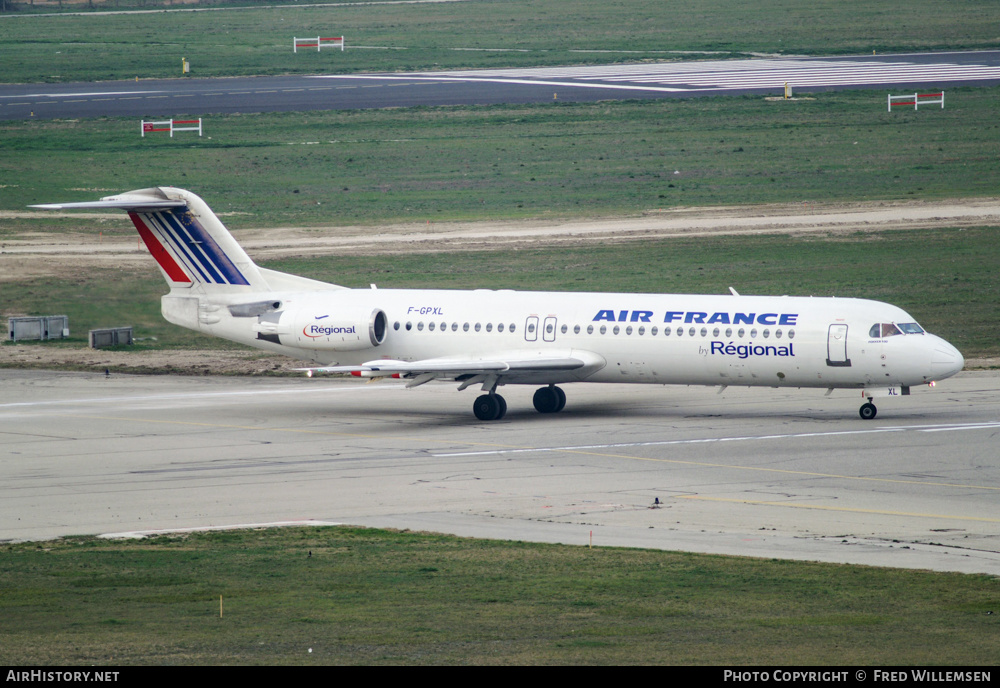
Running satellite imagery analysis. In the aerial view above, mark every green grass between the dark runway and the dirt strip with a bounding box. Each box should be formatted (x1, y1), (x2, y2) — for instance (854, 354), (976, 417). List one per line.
(0, 88), (1000, 228)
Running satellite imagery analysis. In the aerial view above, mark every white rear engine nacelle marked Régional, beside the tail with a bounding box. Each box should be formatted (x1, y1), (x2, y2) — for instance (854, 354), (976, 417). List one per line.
(258, 308), (388, 351)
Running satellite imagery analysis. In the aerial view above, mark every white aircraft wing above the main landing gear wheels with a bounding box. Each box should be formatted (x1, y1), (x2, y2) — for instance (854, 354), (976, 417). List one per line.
(300, 350), (606, 389)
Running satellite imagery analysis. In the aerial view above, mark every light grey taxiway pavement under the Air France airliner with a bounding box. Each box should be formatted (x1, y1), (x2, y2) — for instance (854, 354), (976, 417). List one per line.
(0, 370), (1000, 575)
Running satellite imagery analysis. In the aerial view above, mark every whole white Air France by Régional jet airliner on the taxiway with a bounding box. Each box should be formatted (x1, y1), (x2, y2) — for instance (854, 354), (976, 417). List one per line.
(34, 187), (965, 421)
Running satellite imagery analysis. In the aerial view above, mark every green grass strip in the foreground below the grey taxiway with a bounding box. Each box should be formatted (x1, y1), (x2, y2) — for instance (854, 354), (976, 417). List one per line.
(0, 528), (1000, 667)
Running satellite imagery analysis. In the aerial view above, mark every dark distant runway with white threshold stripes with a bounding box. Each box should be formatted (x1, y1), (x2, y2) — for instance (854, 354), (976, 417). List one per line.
(0, 50), (1000, 120)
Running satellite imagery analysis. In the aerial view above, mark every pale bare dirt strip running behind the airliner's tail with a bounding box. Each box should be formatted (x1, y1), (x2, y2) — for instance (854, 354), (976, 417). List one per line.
(7, 199), (1000, 283)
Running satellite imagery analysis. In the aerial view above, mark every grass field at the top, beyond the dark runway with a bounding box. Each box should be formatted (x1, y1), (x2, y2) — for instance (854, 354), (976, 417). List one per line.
(0, 0), (1000, 83)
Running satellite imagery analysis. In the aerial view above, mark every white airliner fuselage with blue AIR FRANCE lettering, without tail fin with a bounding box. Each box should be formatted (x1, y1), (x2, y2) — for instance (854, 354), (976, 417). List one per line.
(174, 289), (963, 388)
